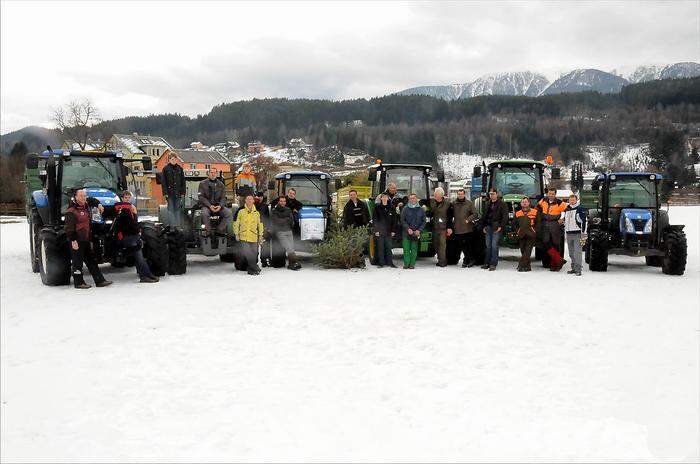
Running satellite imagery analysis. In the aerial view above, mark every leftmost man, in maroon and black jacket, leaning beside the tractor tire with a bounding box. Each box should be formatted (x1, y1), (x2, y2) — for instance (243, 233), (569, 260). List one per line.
(64, 189), (112, 289)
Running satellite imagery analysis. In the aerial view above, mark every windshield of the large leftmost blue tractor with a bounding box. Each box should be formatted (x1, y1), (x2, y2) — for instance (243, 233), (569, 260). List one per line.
(62, 156), (118, 191)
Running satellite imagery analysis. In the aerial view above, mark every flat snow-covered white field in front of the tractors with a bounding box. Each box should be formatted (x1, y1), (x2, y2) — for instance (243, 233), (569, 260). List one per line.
(0, 207), (700, 462)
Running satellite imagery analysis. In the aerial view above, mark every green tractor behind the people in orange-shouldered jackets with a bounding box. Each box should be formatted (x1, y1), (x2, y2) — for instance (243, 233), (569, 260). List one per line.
(472, 159), (565, 264)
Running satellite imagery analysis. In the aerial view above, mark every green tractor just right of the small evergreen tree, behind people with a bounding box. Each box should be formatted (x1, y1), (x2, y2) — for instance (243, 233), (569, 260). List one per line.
(364, 160), (445, 264)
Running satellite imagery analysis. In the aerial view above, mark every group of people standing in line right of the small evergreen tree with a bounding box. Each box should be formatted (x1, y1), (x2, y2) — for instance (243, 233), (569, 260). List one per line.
(342, 183), (587, 276)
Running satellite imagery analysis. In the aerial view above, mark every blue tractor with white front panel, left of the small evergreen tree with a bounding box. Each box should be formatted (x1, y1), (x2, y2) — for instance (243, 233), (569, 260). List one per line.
(267, 171), (341, 267)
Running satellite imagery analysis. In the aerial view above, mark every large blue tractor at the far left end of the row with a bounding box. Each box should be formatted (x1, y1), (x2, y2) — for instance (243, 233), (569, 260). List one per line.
(24, 147), (185, 285)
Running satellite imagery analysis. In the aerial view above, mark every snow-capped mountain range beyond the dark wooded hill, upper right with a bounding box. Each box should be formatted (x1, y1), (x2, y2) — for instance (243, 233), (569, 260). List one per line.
(395, 62), (700, 100)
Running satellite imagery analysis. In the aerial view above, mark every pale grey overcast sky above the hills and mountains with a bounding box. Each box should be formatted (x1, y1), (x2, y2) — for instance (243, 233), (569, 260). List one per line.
(0, 0), (700, 133)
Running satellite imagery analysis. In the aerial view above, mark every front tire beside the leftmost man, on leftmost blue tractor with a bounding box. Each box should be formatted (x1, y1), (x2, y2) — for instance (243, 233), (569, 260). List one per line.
(38, 227), (71, 286)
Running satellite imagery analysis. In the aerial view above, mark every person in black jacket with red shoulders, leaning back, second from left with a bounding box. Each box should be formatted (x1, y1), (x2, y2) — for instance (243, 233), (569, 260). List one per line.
(113, 191), (159, 284)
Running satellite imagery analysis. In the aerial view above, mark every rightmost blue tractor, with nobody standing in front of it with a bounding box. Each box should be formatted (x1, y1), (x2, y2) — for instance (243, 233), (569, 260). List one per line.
(584, 172), (688, 275)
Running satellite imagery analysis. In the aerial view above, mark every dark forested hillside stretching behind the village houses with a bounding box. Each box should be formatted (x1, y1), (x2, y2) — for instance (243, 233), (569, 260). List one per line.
(78, 77), (700, 162)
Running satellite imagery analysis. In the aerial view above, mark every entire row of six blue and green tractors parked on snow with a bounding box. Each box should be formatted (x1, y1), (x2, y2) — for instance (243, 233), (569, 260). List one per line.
(25, 147), (687, 285)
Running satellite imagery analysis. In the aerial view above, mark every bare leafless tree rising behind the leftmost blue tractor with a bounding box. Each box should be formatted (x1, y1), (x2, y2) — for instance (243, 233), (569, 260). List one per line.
(52, 98), (107, 150)
